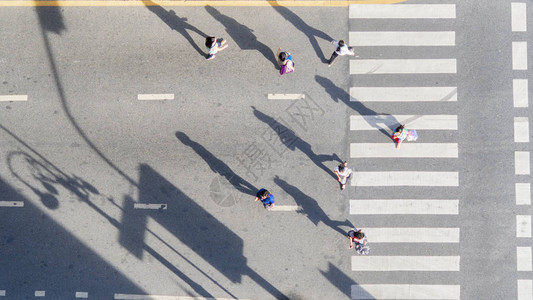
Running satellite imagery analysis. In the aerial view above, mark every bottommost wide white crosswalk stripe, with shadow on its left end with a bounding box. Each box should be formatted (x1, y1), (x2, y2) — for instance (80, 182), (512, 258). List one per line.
(351, 284), (461, 300)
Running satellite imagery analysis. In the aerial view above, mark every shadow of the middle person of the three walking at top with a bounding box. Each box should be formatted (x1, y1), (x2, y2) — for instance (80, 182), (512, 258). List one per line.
(205, 5), (279, 68)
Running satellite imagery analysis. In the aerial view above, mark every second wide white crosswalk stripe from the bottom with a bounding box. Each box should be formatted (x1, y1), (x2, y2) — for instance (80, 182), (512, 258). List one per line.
(352, 256), (460, 272)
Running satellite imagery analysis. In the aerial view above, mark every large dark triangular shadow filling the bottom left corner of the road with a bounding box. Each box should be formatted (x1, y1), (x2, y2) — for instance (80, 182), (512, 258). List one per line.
(0, 177), (145, 299)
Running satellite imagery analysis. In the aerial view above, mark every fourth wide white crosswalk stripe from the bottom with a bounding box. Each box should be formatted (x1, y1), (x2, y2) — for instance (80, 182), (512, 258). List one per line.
(350, 199), (459, 215)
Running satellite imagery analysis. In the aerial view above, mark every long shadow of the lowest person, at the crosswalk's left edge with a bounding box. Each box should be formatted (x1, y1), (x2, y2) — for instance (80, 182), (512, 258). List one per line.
(274, 176), (353, 236)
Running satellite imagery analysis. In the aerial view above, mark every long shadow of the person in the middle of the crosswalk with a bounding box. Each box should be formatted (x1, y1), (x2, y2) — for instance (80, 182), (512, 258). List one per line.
(315, 75), (399, 139)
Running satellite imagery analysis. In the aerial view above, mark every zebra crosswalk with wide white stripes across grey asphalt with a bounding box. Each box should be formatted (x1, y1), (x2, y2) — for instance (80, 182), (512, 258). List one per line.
(349, 4), (460, 299)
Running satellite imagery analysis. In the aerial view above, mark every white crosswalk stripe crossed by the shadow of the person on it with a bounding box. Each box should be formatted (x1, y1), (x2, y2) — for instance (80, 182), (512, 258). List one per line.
(350, 115), (457, 130)
